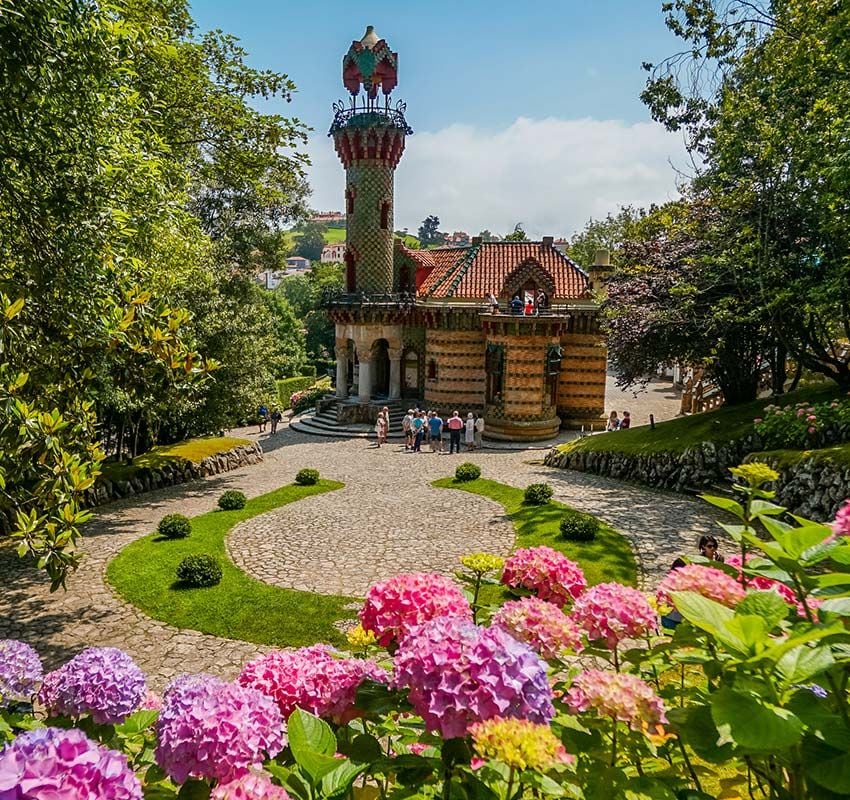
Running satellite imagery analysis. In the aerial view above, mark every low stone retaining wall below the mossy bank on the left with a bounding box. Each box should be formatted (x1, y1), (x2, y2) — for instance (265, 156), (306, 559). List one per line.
(86, 442), (263, 506)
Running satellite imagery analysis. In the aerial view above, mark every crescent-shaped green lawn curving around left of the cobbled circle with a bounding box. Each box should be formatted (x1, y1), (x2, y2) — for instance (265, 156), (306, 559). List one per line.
(107, 480), (354, 647)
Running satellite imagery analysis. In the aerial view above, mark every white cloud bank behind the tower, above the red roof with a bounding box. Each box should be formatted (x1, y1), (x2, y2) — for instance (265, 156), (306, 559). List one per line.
(302, 117), (687, 238)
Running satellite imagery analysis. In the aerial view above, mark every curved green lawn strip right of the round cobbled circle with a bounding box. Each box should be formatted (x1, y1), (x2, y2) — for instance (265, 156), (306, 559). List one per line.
(432, 478), (637, 603)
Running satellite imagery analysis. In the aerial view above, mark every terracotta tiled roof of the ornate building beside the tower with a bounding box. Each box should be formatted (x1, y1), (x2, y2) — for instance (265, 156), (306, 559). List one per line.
(412, 242), (588, 300)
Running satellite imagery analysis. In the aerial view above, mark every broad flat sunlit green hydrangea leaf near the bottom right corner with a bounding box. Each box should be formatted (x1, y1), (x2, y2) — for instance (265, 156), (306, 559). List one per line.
(711, 687), (803, 753)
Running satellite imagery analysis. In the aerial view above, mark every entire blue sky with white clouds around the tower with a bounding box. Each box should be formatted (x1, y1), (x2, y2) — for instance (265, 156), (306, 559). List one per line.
(192, 0), (686, 236)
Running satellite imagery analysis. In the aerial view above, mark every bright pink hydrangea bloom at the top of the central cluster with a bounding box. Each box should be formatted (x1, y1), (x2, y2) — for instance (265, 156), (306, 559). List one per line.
(502, 547), (587, 607)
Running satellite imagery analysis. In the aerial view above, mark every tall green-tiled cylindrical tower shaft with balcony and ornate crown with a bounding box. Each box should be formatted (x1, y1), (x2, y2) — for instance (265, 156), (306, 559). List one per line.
(329, 25), (413, 294)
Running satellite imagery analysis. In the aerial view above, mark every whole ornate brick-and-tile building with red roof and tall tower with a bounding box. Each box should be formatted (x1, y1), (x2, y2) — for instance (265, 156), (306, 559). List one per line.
(318, 28), (606, 441)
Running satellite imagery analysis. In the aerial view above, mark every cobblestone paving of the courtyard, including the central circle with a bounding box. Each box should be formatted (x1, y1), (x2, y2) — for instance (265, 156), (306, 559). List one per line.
(0, 428), (715, 688)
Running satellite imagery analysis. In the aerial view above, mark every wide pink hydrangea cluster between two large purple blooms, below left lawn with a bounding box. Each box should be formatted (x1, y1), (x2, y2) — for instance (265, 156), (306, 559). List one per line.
(237, 644), (389, 724)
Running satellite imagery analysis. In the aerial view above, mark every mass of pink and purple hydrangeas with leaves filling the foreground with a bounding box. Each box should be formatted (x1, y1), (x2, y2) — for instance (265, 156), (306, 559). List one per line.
(0, 464), (850, 800)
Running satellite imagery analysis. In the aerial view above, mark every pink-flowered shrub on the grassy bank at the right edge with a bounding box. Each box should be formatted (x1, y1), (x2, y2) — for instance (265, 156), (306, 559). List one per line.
(753, 398), (850, 450)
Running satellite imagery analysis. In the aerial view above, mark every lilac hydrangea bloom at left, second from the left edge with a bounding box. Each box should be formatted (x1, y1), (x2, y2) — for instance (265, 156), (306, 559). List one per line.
(38, 647), (147, 725)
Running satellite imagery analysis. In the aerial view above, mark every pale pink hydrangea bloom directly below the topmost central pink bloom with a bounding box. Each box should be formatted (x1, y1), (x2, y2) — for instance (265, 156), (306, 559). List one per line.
(491, 597), (584, 659)
